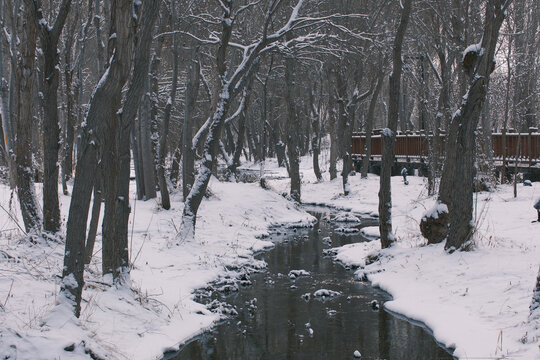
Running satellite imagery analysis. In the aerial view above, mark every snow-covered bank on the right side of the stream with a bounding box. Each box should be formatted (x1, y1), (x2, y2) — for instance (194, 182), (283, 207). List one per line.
(270, 159), (540, 359)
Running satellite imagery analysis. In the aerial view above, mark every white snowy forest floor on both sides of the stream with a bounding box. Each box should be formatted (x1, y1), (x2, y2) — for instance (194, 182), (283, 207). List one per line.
(0, 158), (540, 359)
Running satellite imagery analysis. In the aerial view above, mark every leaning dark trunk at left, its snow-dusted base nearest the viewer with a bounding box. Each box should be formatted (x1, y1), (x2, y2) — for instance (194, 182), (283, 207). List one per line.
(60, 0), (132, 317)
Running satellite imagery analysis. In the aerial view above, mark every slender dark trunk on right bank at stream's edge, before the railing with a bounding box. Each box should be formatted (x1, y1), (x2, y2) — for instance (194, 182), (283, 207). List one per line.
(379, 0), (412, 249)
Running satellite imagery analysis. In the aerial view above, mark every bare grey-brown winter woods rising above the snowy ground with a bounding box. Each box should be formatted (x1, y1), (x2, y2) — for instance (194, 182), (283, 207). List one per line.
(0, 0), (540, 358)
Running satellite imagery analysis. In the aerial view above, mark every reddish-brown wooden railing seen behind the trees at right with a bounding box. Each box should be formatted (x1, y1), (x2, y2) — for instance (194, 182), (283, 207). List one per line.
(352, 128), (540, 165)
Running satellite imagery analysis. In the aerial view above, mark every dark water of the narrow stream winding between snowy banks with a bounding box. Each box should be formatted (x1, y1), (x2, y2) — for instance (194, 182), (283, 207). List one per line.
(165, 208), (452, 360)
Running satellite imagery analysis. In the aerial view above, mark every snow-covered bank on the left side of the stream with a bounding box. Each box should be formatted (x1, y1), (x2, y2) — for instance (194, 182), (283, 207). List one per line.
(0, 179), (314, 360)
